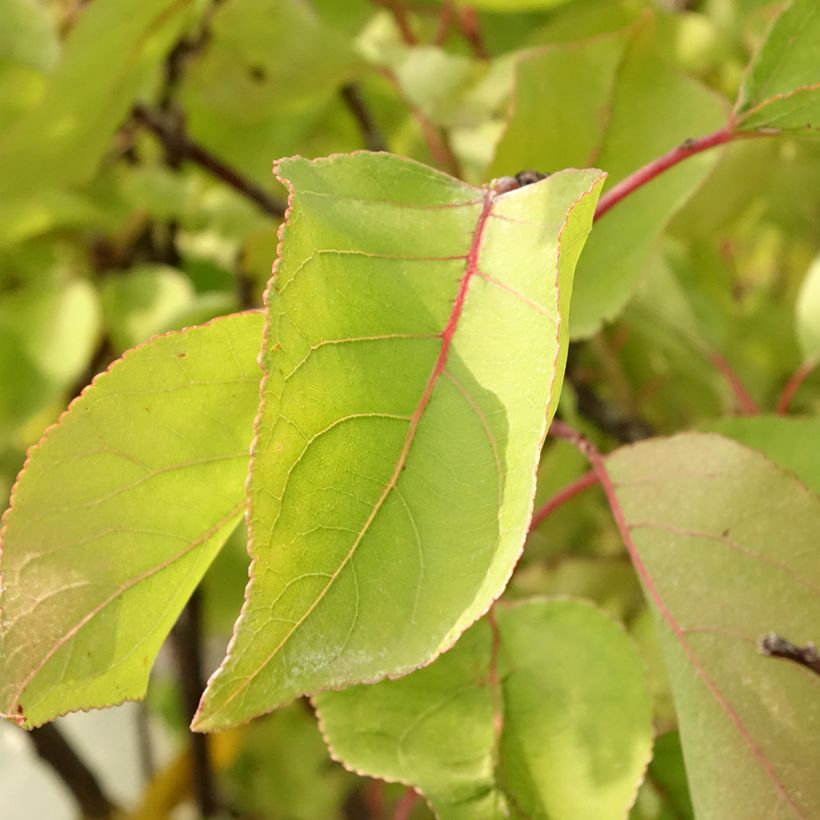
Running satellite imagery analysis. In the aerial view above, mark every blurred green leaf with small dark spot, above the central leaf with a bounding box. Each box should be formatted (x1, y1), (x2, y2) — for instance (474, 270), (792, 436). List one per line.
(180, 0), (364, 179)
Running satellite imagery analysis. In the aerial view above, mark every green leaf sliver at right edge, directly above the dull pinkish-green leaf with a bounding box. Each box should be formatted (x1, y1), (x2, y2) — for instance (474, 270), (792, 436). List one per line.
(701, 416), (820, 493)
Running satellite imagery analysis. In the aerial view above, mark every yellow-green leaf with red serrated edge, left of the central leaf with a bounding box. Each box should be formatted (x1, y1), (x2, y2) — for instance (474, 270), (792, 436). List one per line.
(0, 313), (262, 726)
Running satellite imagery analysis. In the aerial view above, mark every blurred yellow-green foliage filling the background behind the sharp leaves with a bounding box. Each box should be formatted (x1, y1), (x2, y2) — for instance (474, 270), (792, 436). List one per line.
(0, 0), (820, 820)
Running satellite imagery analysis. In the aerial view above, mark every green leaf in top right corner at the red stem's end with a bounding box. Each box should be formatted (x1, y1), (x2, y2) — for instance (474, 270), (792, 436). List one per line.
(734, 0), (820, 131)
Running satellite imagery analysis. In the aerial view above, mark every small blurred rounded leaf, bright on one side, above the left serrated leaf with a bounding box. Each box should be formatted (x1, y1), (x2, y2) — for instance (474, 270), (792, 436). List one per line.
(101, 265), (195, 350)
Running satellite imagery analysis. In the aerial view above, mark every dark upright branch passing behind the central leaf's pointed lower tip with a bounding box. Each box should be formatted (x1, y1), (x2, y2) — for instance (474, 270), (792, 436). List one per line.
(171, 589), (217, 817)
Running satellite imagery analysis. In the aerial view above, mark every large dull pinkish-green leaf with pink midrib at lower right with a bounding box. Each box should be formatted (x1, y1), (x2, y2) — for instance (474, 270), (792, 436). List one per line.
(607, 434), (820, 818)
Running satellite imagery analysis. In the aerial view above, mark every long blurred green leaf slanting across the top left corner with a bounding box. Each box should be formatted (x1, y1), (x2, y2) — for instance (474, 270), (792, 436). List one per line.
(0, 0), (195, 197)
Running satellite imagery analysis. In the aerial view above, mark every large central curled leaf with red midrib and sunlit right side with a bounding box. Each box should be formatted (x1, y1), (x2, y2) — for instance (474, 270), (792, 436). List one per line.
(194, 153), (602, 730)
